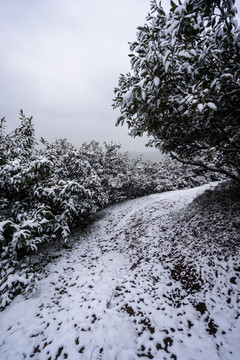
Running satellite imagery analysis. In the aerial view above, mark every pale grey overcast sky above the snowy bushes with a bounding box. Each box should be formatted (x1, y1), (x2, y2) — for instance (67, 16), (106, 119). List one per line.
(0, 0), (240, 151)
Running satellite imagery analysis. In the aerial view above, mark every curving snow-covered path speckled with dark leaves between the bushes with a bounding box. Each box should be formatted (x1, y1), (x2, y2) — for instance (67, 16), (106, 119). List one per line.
(0, 185), (240, 360)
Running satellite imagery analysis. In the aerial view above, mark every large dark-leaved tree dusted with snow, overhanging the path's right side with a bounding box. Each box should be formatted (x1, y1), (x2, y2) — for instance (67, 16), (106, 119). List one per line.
(113, 0), (240, 181)
